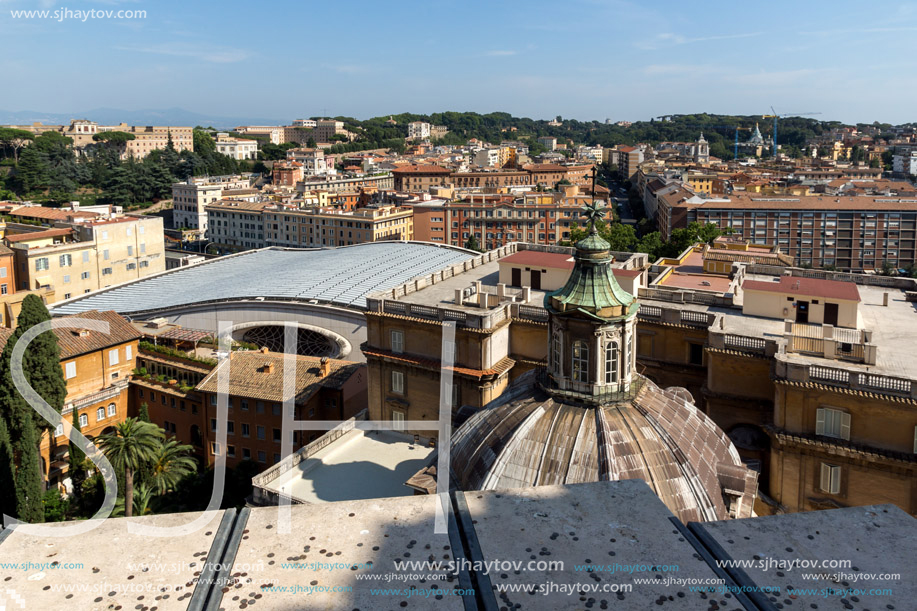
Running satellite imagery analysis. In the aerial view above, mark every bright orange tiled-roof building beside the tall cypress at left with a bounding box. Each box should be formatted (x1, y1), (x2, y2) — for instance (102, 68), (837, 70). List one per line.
(39, 310), (140, 491)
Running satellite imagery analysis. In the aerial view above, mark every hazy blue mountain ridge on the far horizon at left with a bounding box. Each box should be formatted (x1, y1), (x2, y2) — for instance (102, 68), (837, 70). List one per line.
(0, 108), (282, 129)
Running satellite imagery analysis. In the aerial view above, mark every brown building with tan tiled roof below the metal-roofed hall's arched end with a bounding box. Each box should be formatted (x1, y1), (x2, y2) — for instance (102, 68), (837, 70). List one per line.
(196, 349), (367, 467)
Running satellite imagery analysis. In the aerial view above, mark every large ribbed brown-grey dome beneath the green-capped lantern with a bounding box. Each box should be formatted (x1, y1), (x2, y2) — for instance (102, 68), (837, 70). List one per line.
(451, 372), (757, 523)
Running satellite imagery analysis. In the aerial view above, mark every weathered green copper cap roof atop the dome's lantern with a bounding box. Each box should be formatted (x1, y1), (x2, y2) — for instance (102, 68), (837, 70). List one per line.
(545, 231), (638, 321)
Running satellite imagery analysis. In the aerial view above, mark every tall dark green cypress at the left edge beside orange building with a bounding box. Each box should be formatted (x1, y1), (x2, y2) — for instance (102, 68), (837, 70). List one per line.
(0, 295), (67, 522)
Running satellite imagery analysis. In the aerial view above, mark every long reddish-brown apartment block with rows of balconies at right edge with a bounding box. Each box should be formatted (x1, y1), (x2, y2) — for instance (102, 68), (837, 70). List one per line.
(659, 193), (917, 271)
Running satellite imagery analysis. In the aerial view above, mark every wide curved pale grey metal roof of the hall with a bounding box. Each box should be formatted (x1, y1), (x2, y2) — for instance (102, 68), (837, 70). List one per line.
(52, 242), (476, 316)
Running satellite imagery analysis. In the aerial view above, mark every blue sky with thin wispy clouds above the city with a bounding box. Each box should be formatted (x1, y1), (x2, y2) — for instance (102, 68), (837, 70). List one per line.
(0, 0), (917, 124)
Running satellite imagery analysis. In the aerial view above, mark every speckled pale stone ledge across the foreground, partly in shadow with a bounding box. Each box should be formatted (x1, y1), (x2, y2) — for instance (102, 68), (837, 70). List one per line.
(0, 480), (917, 611)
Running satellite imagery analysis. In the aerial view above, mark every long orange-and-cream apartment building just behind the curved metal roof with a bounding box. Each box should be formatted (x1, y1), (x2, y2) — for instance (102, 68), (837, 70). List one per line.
(413, 187), (592, 249)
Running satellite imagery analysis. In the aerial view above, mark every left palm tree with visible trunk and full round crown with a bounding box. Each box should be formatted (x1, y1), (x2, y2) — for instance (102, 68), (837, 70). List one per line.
(95, 418), (165, 518)
